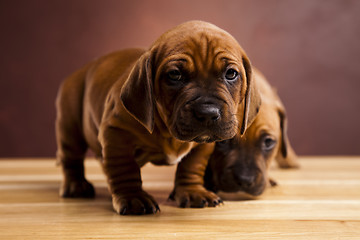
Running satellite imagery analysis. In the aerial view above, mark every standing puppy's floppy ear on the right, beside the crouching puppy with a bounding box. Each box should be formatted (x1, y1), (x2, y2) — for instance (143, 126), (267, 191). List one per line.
(240, 56), (261, 135)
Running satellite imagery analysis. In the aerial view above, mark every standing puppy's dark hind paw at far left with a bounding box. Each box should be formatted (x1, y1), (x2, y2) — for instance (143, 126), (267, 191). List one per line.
(60, 179), (95, 198)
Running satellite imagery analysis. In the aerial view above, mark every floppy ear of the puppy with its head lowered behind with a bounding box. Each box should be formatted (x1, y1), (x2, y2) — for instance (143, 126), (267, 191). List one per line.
(275, 108), (299, 168)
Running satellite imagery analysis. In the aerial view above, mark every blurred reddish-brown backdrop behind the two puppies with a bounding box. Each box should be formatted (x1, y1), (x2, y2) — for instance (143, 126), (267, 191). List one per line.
(0, 0), (360, 157)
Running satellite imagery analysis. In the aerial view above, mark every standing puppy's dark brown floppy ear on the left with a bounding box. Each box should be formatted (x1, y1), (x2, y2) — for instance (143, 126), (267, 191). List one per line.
(120, 52), (154, 133)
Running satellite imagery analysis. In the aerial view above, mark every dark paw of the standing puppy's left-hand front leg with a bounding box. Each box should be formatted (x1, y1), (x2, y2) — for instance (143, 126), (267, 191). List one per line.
(112, 191), (160, 215)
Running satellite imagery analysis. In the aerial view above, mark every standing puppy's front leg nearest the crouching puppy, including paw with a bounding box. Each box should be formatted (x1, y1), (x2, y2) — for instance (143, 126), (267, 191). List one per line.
(171, 144), (222, 208)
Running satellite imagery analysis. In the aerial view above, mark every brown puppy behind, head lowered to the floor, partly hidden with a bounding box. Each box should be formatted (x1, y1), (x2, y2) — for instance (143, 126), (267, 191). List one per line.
(205, 68), (298, 196)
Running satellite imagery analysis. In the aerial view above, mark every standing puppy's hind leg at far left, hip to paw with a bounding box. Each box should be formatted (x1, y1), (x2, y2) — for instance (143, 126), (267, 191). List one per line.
(55, 71), (95, 198)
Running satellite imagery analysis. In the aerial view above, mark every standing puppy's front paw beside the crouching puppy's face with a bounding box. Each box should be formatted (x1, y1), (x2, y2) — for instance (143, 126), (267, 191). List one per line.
(170, 186), (223, 208)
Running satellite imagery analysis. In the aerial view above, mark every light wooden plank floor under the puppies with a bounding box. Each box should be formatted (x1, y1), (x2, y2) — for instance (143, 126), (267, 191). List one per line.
(0, 157), (360, 240)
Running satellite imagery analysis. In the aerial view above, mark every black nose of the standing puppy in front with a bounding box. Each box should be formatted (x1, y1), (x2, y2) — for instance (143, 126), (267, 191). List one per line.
(193, 103), (220, 124)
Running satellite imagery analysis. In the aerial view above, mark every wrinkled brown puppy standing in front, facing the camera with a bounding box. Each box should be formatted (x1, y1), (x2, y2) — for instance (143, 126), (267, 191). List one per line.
(56, 21), (258, 214)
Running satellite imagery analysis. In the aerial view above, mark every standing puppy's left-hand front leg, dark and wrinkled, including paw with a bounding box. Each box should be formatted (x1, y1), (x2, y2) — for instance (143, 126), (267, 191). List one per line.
(99, 127), (159, 215)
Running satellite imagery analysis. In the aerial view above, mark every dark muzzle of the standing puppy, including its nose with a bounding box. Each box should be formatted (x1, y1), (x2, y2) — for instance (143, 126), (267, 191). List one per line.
(169, 96), (238, 143)
